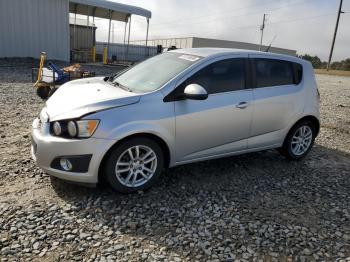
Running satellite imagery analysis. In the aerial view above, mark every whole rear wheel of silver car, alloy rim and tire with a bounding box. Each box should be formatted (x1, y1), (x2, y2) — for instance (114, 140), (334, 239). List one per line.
(280, 121), (316, 160)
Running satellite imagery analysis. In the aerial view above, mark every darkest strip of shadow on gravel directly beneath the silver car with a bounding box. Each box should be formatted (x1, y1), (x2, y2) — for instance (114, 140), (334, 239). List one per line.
(51, 145), (350, 202)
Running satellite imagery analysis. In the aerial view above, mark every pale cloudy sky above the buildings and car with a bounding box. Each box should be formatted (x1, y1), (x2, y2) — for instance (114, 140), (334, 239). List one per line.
(91, 0), (350, 60)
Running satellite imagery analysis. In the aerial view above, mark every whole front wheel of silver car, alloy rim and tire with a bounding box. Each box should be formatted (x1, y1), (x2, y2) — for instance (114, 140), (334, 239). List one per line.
(104, 138), (164, 193)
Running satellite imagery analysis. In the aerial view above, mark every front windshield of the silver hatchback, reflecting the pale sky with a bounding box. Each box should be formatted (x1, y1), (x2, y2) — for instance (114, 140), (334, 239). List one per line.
(113, 52), (202, 93)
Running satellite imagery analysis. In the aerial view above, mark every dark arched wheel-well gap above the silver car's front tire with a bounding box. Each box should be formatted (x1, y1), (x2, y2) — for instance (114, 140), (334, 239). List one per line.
(98, 133), (171, 182)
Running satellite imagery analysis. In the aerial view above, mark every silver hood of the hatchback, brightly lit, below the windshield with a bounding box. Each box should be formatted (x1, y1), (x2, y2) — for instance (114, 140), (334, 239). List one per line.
(46, 77), (140, 121)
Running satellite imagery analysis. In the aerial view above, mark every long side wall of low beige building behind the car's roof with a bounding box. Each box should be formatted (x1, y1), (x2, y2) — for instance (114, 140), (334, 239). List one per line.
(192, 37), (296, 56)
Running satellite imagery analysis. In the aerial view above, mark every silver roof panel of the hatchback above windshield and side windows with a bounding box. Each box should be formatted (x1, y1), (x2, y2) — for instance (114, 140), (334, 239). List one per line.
(171, 47), (304, 62)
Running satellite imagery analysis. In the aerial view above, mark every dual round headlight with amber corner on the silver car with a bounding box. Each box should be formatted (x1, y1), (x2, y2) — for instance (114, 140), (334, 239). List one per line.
(51, 120), (100, 138)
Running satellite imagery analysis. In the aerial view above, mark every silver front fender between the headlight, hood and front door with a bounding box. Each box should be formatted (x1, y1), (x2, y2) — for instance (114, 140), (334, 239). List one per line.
(85, 94), (175, 165)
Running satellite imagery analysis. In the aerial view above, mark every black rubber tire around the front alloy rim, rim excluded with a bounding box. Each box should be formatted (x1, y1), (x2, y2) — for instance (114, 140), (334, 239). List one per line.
(103, 137), (164, 194)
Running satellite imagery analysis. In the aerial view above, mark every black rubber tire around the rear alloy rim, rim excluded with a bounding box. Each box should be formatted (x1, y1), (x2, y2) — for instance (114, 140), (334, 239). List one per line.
(279, 120), (316, 161)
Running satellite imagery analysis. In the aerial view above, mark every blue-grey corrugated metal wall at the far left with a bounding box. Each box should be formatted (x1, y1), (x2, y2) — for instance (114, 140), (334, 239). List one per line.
(0, 0), (70, 61)
